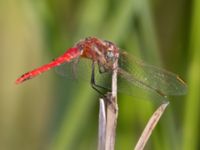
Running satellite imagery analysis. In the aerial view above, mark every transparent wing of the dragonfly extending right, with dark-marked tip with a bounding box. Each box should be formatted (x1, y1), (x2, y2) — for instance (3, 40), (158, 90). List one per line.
(119, 51), (187, 96)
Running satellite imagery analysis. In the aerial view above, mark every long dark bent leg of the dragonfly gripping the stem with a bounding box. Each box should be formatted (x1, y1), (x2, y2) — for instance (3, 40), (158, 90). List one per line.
(90, 62), (110, 96)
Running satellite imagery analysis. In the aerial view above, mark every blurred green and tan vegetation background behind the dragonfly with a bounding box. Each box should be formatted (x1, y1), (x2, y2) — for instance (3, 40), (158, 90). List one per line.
(0, 0), (200, 150)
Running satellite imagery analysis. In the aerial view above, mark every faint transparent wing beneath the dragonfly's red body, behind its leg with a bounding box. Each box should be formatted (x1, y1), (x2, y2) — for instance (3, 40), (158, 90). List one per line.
(55, 58), (111, 86)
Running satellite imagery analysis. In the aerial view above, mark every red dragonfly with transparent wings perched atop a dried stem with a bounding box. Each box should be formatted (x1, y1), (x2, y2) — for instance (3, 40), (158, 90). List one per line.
(16, 37), (187, 97)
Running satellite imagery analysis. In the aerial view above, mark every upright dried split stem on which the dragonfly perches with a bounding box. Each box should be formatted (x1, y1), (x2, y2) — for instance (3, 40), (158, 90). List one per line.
(98, 54), (118, 150)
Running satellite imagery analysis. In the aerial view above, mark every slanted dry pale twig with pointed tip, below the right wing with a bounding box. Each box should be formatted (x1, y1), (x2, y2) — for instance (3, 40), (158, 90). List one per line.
(134, 102), (169, 150)
